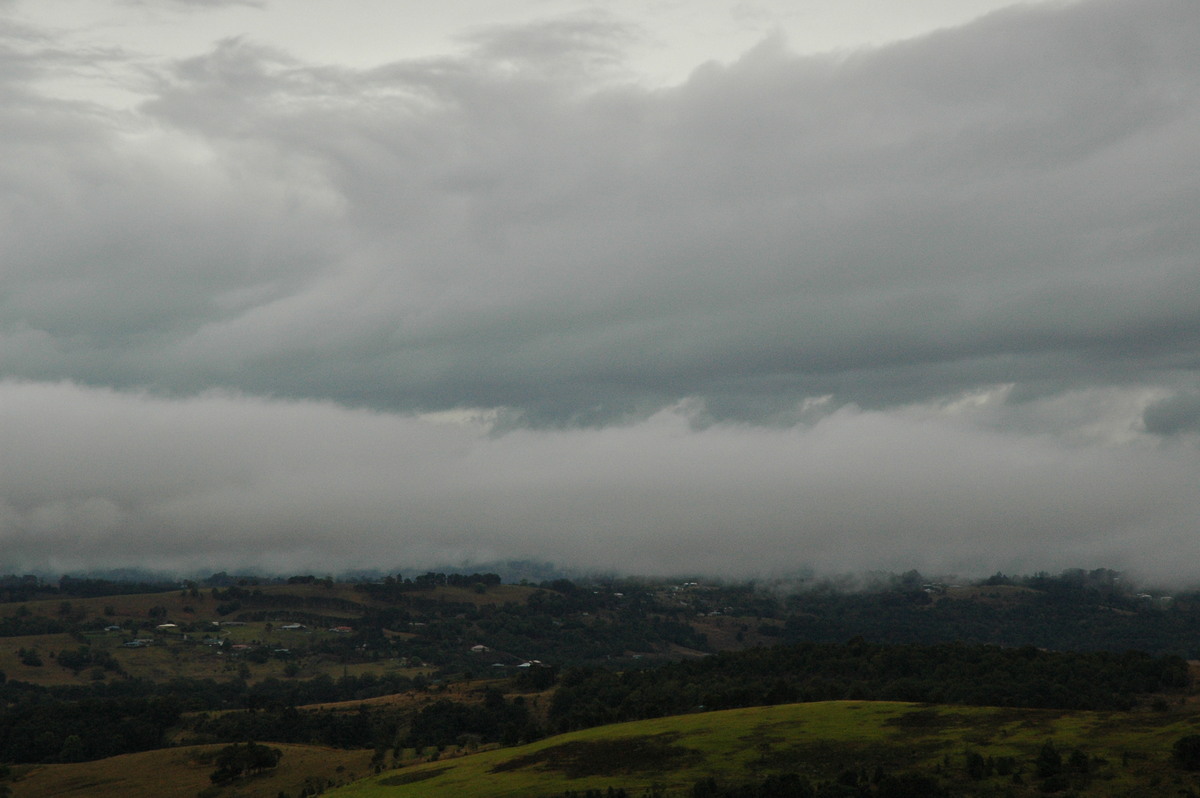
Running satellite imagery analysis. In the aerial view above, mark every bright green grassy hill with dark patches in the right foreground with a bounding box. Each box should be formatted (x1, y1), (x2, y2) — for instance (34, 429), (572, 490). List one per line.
(328, 702), (1200, 798)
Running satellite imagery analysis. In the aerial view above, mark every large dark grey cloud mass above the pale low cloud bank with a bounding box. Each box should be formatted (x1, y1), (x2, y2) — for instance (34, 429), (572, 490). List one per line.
(4, 0), (1200, 424)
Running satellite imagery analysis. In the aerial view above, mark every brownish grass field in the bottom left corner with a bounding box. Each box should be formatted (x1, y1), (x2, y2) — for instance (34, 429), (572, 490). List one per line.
(12, 744), (371, 798)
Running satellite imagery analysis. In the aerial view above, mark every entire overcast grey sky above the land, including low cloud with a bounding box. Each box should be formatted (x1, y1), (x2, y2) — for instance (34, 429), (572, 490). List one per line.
(0, 0), (1200, 583)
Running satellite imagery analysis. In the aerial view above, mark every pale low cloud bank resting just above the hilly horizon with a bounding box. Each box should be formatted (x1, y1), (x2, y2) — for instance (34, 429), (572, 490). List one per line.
(0, 382), (1200, 578)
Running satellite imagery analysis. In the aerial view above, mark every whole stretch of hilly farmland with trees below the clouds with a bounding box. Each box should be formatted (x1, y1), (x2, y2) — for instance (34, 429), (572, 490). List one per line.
(0, 574), (1200, 798)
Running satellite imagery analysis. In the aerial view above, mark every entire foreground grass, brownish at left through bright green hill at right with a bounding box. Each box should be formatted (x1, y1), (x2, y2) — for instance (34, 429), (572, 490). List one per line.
(12, 701), (1200, 798)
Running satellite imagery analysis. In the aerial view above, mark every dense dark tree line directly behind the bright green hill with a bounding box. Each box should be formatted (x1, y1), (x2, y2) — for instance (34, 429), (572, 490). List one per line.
(550, 638), (1189, 731)
